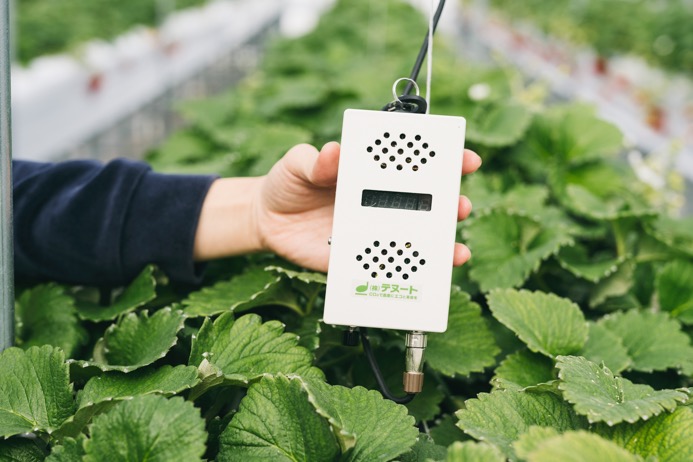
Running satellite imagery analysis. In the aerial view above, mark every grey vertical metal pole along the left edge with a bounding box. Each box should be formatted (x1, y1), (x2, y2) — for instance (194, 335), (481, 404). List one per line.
(0, 0), (14, 351)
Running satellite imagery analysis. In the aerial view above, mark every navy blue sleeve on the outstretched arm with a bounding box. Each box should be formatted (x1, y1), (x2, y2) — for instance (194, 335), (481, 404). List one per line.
(12, 160), (215, 286)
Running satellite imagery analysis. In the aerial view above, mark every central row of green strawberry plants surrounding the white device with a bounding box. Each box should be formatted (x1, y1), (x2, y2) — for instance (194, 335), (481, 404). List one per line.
(0, 0), (693, 462)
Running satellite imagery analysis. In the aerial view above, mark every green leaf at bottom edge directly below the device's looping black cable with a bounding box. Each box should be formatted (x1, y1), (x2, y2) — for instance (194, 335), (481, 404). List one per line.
(304, 380), (419, 462)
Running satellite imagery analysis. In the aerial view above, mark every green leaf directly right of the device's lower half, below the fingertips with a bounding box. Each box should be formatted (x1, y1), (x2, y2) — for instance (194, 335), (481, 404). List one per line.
(464, 210), (573, 292)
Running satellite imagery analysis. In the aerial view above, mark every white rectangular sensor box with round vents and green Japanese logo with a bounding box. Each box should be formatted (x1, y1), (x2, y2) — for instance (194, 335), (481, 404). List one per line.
(324, 109), (465, 332)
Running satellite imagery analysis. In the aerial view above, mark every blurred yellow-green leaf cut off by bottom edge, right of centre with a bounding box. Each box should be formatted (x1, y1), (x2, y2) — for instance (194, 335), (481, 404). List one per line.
(526, 430), (642, 462)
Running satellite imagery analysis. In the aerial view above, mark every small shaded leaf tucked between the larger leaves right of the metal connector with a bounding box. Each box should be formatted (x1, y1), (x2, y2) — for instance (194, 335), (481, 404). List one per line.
(491, 350), (556, 390)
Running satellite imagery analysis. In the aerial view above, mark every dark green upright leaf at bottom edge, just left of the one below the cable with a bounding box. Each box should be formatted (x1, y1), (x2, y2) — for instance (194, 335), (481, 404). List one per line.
(217, 375), (340, 462)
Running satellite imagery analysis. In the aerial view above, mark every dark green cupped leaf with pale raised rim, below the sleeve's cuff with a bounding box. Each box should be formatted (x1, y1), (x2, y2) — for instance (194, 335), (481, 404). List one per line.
(70, 308), (185, 372)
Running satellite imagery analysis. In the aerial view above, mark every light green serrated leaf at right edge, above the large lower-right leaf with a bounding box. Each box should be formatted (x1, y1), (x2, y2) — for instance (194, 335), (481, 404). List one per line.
(597, 310), (693, 372)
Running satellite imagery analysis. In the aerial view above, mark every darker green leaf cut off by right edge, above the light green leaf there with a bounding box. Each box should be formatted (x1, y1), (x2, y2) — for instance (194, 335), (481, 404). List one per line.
(656, 260), (693, 325)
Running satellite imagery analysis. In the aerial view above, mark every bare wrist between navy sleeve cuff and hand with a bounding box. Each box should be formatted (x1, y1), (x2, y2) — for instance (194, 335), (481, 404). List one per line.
(193, 177), (264, 261)
